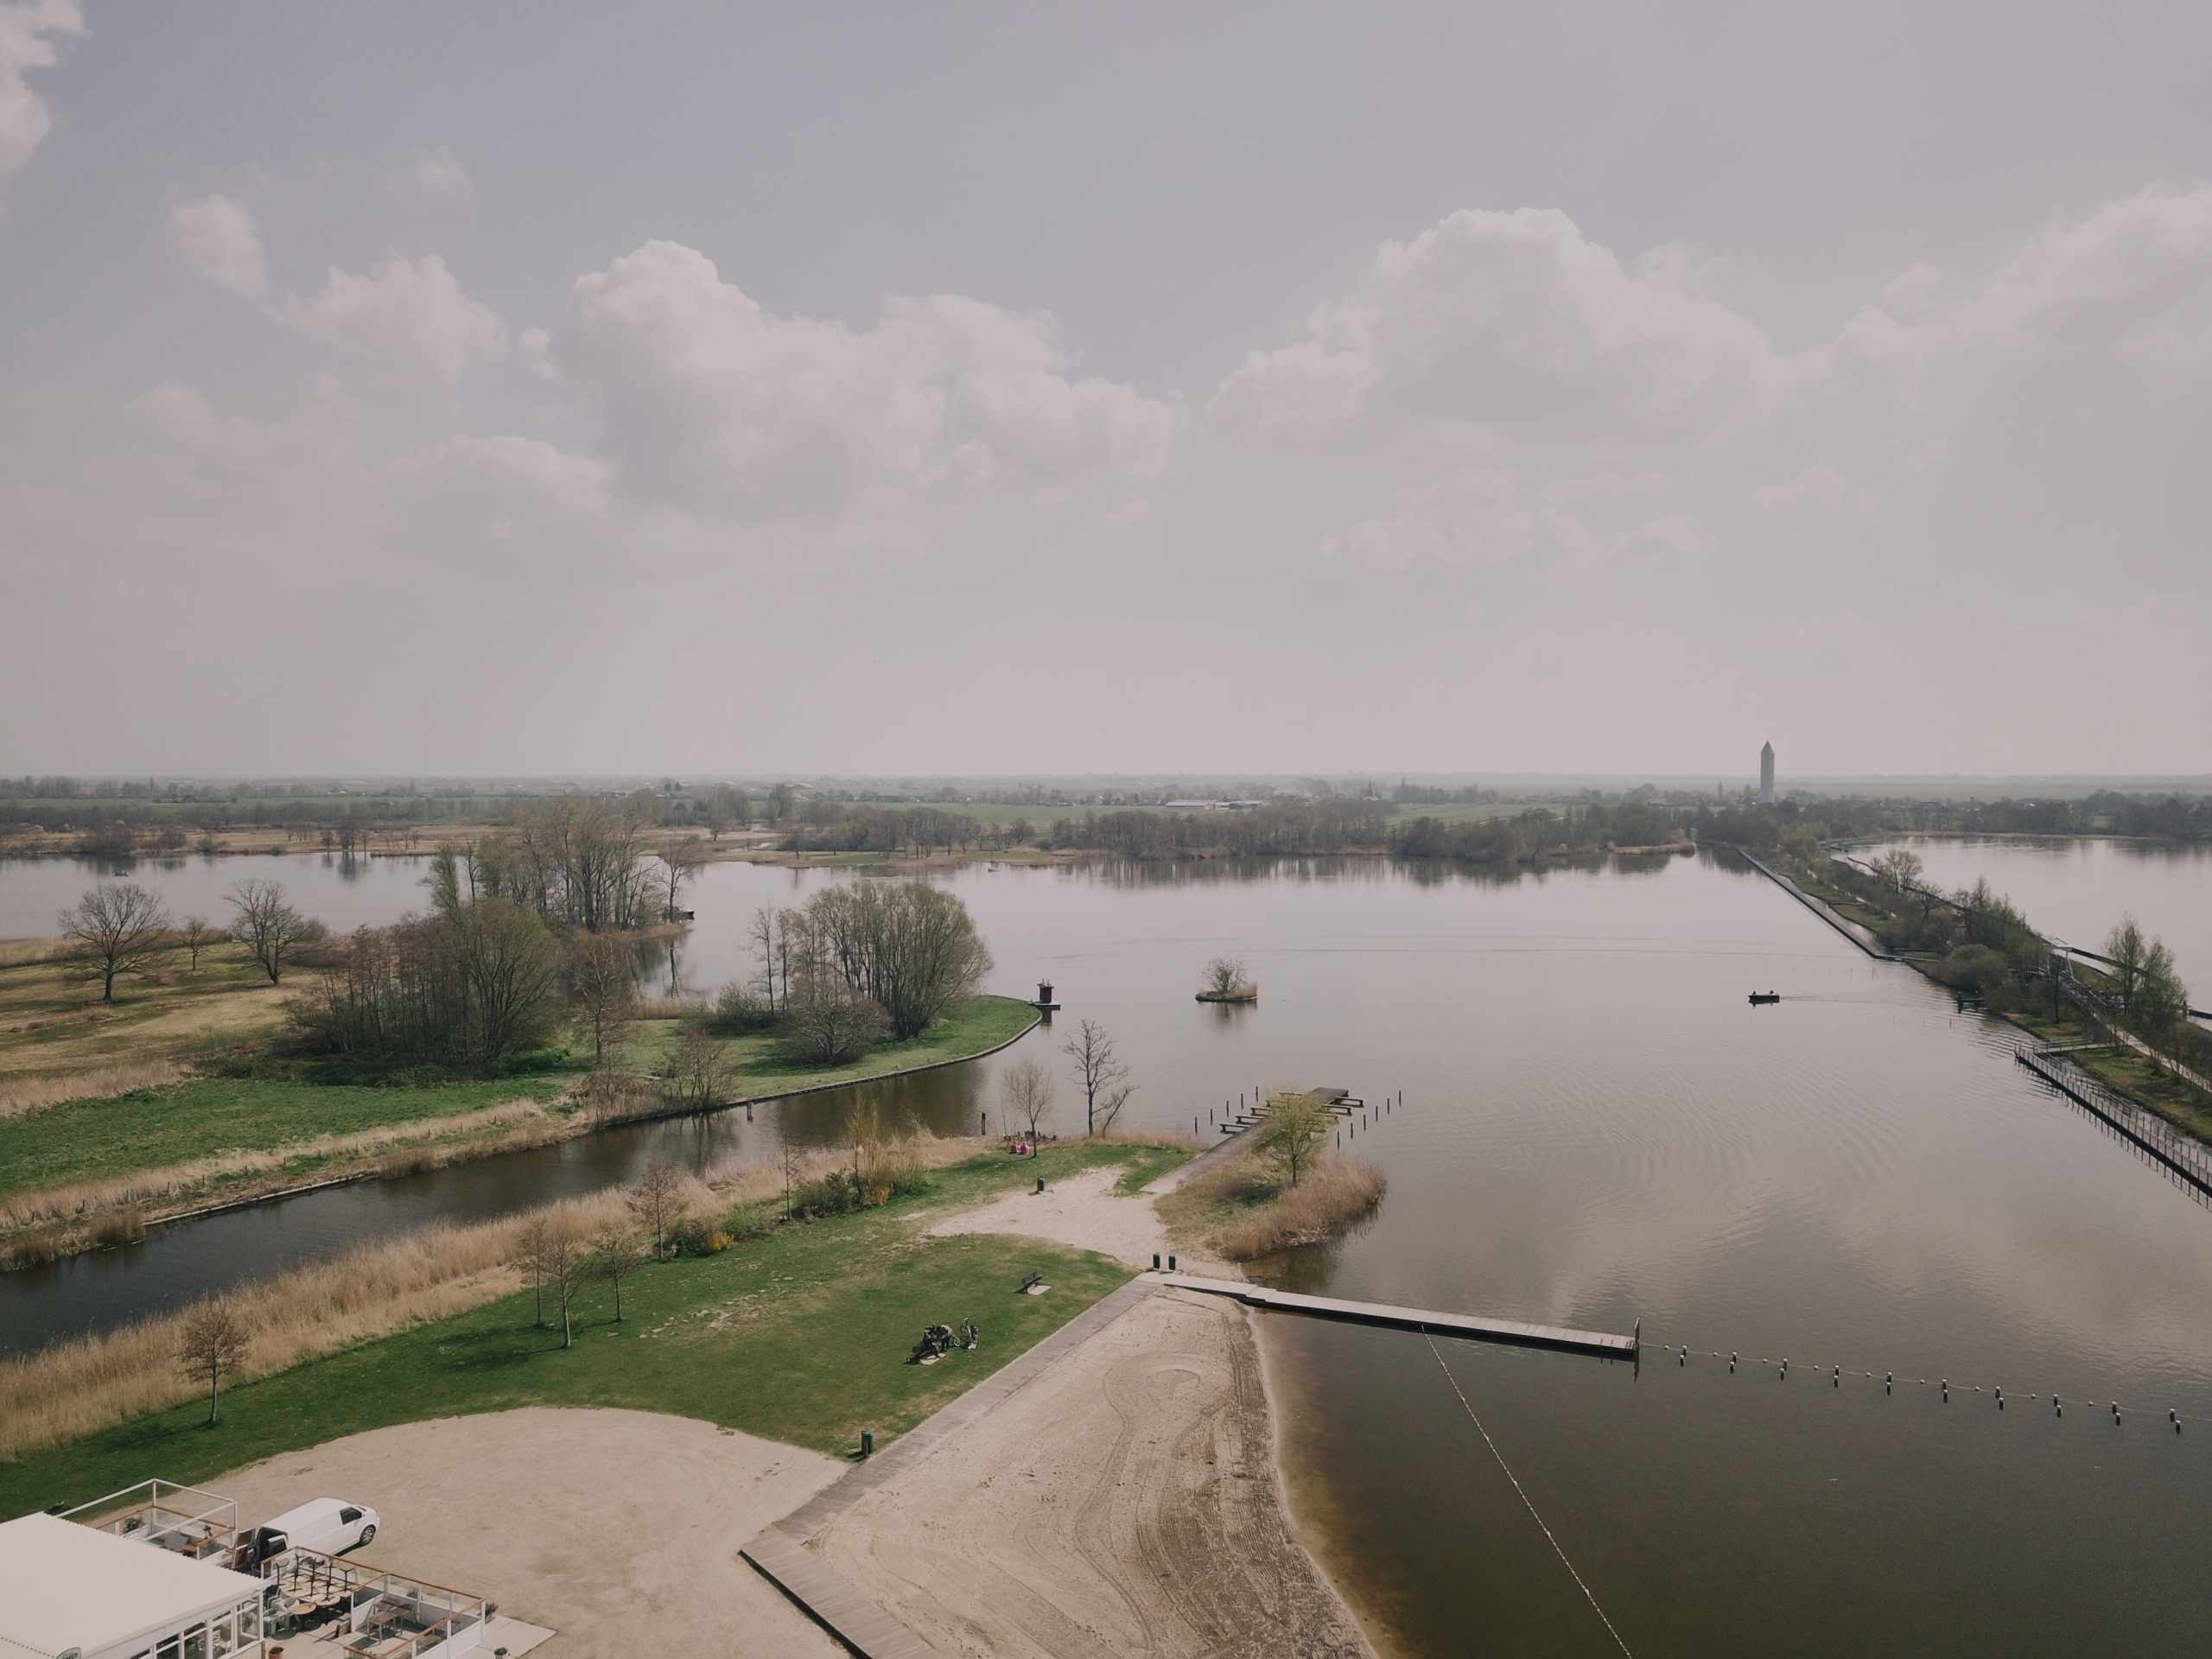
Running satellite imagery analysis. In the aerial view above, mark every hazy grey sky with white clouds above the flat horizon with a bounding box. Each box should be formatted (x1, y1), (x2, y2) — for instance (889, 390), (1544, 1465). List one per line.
(0, 0), (2212, 779)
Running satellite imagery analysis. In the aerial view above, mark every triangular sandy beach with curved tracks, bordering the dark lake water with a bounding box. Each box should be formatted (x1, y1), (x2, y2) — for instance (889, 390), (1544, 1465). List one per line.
(810, 1289), (1371, 1659)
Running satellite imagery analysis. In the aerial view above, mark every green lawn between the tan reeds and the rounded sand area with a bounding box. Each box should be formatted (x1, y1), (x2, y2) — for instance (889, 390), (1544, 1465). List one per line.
(0, 1146), (1188, 1516)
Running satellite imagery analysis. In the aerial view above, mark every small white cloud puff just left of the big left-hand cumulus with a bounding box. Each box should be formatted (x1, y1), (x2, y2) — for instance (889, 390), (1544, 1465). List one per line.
(272, 254), (506, 394)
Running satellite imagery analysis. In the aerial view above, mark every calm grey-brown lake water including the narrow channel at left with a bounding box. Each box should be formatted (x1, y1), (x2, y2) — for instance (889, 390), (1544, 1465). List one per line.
(0, 852), (2212, 1655)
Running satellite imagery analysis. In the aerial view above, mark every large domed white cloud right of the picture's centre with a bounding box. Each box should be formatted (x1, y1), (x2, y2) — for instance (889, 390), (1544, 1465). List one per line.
(1208, 208), (1818, 449)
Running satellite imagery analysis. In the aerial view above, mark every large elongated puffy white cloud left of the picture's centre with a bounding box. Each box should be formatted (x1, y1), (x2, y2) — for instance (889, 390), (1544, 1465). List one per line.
(550, 241), (1184, 518)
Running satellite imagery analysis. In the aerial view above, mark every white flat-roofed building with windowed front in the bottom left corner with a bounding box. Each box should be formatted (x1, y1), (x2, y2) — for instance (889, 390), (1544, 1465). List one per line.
(0, 1516), (264, 1659)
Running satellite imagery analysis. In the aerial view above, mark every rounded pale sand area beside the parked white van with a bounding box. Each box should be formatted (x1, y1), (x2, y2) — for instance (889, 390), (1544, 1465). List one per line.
(208, 1407), (845, 1659)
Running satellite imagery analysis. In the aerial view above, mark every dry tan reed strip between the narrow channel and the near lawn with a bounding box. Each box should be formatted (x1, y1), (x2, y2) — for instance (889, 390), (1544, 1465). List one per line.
(0, 1123), (980, 1462)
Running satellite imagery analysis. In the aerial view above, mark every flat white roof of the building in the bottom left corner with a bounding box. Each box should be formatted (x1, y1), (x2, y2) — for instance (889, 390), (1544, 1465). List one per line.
(0, 1516), (261, 1655)
